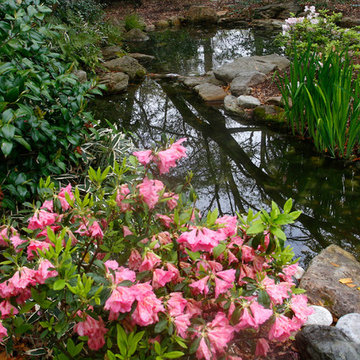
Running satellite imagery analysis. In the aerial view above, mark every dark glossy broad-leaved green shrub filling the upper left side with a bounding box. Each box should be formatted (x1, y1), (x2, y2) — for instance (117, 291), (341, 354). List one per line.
(0, 0), (98, 208)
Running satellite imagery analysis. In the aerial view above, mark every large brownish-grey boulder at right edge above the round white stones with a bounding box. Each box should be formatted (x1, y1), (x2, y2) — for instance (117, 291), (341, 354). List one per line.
(300, 245), (360, 318)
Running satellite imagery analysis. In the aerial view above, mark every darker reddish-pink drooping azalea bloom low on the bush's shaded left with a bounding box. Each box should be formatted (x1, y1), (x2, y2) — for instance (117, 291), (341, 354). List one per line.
(74, 314), (108, 350)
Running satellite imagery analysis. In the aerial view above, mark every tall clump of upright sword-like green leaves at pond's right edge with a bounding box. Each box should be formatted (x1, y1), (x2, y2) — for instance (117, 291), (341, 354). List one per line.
(279, 45), (360, 158)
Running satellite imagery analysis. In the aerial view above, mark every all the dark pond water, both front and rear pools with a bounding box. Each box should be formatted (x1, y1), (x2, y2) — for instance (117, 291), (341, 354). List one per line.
(92, 29), (360, 264)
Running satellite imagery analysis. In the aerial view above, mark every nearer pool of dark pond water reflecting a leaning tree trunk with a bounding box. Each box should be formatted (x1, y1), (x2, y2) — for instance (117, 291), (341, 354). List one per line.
(91, 79), (360, 262)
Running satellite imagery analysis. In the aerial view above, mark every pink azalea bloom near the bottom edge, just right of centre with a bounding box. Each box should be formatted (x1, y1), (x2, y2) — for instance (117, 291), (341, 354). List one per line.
(207, 312), (234, 354)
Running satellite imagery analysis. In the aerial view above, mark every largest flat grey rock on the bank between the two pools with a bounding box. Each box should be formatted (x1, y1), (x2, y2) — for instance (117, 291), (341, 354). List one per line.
(214, 54), (290, 83)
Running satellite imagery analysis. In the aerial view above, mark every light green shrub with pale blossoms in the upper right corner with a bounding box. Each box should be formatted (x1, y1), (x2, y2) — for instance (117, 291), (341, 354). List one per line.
(277, 10), (360, 57)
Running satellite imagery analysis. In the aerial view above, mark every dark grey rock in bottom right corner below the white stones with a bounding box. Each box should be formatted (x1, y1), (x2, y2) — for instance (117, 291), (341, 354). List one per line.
(295, 325), (360, 360)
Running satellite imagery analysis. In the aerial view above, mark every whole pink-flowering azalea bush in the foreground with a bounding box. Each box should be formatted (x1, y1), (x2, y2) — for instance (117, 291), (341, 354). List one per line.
(0, 139), (311, 360)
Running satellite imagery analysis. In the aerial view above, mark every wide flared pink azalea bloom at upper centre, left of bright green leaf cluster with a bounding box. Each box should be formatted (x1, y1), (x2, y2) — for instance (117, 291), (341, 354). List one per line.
(177, 228), (221, 252)
